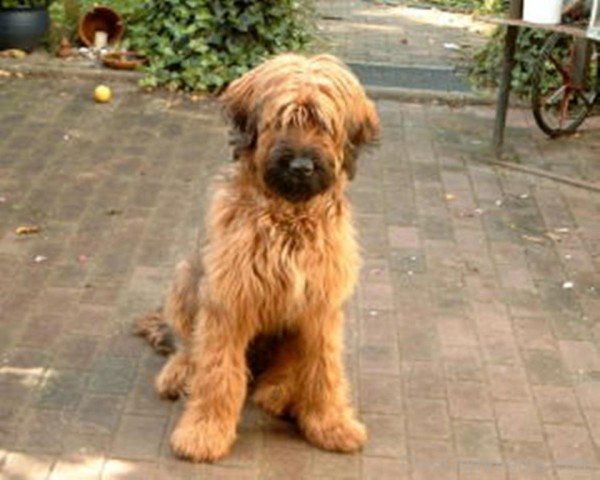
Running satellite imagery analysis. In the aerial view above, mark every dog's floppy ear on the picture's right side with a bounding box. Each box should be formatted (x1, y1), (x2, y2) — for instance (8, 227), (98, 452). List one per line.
(343, 98), (379, 180)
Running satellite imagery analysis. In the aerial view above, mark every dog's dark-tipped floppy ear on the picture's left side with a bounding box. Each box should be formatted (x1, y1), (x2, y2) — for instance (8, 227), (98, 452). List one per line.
(219, 69), (257, 158)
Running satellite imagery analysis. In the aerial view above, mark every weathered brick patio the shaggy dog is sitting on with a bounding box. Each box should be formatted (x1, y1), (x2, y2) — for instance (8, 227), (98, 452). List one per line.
(0, 79), (600, 480)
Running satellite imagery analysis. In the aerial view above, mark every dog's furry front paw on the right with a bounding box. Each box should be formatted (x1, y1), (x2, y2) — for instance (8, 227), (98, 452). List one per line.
(300, 414), (367, 453)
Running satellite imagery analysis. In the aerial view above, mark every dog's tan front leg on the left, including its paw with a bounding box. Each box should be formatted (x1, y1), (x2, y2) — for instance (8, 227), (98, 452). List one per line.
(171, 308), (248, 462)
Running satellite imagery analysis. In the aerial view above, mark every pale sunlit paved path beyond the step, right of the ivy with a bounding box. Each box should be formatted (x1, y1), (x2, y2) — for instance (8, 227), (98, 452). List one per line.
(317, 0), (494, 67)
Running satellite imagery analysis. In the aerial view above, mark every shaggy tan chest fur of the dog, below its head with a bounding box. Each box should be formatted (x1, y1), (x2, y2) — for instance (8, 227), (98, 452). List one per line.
(204, 172), (358, 329)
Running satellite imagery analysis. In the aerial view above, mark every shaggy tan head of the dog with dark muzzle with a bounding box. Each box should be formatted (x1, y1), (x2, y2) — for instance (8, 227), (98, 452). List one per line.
(221, 54), (379, 202)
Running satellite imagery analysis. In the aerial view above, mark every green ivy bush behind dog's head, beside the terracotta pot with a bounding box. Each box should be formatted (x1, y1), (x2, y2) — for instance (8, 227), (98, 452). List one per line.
(127, 0), (314, 91)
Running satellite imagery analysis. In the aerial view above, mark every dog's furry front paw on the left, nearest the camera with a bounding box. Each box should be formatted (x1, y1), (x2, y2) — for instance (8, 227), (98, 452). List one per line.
(171, 420), (235, 462)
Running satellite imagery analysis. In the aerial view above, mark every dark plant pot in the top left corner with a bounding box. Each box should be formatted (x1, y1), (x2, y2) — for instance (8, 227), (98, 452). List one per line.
(0, 8), (50, 52)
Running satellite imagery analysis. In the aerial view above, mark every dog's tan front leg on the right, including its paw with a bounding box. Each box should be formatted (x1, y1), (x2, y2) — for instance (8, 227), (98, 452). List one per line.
(294, 311), (367, 452)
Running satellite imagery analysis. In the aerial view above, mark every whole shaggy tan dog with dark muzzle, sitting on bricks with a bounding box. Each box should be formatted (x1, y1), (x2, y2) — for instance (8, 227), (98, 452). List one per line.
(137, 54), (378, 461)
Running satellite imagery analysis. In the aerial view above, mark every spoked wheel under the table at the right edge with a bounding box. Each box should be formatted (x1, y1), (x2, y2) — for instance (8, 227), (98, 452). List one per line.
(531, 32), (600, 138)
